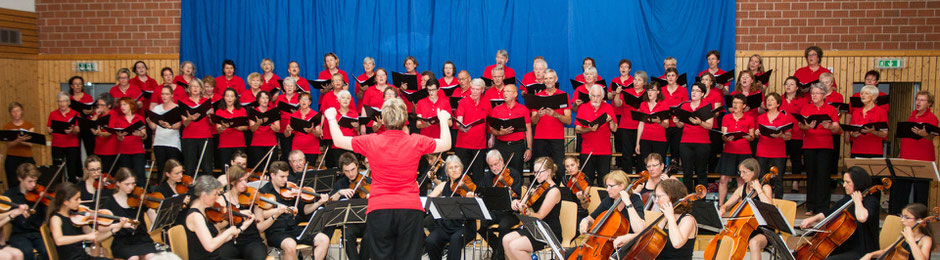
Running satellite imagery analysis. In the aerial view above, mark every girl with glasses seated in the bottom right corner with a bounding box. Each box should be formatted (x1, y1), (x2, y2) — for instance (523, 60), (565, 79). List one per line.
(861, 203), (933, 260)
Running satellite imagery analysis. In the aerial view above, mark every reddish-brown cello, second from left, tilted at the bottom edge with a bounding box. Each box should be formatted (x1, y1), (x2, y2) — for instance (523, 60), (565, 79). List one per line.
(611, 185), (704, 260)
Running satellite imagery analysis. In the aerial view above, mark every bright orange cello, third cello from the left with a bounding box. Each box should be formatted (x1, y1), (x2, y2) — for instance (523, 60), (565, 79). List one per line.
(705, 167), (778, 259)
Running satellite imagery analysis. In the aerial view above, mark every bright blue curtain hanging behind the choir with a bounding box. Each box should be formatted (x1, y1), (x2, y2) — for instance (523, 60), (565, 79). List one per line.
(180, 0), (735, 108)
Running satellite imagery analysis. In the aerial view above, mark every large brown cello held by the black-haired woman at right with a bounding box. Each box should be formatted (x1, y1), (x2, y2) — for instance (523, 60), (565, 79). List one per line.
(793, 178), (891, 260)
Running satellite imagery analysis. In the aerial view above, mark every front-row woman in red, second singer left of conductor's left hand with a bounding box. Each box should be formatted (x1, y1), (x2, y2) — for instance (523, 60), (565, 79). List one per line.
(248, 91), (281, 168)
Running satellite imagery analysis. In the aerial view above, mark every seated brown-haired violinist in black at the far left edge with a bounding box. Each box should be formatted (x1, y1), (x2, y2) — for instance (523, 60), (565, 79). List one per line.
(0, 163), (47, 260)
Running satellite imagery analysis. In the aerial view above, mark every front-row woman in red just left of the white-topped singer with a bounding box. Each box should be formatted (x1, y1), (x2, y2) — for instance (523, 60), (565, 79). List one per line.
(108, 97), (147, 187)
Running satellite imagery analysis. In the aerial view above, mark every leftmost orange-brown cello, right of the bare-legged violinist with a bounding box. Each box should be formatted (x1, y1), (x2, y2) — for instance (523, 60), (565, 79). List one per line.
(568, 171), (650, 260)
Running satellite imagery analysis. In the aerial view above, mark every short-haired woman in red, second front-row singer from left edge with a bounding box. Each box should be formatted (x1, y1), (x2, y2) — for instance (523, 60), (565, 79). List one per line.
(46, 92), (82, 180)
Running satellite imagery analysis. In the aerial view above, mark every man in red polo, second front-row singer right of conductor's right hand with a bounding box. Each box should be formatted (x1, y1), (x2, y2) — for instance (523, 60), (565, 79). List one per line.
(487, 85), (532, 176)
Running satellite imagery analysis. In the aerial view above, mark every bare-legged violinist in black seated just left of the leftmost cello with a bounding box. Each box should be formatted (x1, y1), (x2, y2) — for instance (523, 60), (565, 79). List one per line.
(503, 157), (561, 260)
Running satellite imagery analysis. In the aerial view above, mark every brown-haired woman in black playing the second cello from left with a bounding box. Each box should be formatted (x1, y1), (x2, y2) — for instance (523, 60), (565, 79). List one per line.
(614, 179), (698, 259)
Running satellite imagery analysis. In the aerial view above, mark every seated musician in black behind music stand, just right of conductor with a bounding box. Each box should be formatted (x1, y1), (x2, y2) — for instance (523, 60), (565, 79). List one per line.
(424, 155), (475, 260)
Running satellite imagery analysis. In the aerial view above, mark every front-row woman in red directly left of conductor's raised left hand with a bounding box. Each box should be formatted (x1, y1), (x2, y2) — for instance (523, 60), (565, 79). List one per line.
(284, 93), (322, 162)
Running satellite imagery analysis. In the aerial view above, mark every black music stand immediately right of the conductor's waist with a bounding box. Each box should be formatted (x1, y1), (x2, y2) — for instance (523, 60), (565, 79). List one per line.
(427, 197), (493, 220)
